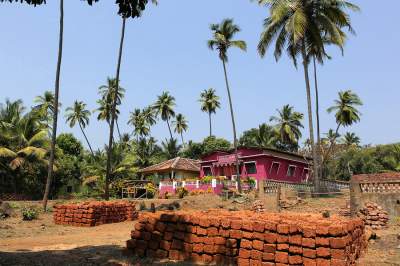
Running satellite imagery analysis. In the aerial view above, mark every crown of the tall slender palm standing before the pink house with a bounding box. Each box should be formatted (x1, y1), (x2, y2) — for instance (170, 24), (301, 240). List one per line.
(208, 19), (247, 62)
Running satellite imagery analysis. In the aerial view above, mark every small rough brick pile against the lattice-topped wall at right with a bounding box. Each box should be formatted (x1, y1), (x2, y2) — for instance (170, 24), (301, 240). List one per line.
(359, 202), (389, 229)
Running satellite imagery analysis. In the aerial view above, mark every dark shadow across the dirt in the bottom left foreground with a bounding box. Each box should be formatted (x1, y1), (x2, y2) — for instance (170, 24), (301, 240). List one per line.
(0, 245), (190, 266)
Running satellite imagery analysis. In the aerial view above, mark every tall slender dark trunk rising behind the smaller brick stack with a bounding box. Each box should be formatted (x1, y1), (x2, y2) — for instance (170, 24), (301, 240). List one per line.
(104, 18), (126, 200)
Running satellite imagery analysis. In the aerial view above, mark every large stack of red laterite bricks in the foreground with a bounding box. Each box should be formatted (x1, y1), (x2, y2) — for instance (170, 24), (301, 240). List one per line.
(127, 210), (366, 266)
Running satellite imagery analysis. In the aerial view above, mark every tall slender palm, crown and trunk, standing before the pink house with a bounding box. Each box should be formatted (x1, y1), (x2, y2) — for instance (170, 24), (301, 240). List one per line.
(208, 19), (247, 193)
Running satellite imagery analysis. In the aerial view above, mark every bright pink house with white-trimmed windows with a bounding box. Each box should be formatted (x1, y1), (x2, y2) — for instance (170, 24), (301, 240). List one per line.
(200, 147), (310, 183)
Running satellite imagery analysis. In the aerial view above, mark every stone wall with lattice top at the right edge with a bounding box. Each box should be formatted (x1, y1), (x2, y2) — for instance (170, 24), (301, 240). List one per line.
(350, 173), (400, 218)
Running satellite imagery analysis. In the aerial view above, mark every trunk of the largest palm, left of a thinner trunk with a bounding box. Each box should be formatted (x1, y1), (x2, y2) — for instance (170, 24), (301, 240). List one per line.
(301, 41), (320, 193)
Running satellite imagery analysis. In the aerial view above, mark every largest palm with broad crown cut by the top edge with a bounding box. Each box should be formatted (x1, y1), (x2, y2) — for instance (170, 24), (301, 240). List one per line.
(258, 0), (353, 191)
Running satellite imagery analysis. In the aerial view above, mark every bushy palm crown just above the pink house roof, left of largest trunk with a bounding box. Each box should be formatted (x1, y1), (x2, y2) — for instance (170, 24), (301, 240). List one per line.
(270, 104), (304, 151)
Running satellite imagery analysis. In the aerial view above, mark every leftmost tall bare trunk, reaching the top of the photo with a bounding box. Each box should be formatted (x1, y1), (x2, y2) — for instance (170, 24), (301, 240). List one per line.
(43, 0), (64, 211)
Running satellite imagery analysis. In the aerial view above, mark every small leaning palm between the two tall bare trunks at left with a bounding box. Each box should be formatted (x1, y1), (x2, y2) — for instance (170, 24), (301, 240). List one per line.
(65, 101), (94, 157)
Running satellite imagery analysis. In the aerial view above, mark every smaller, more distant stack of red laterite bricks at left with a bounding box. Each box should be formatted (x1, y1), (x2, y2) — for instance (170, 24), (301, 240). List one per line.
(53, 201), (138, 226)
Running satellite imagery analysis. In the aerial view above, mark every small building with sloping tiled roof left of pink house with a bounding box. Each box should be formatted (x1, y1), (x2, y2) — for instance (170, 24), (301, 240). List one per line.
(139, 157), (200, 181)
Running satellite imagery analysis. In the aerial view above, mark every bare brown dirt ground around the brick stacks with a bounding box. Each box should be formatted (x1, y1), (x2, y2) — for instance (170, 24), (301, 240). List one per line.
(0, 195), (400, 266)
